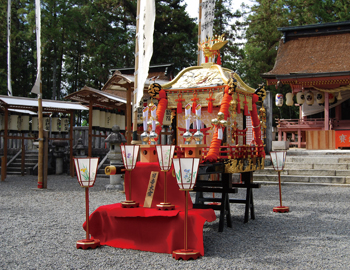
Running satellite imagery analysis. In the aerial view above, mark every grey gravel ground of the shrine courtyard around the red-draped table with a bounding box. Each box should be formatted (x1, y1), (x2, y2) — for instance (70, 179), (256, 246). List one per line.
(0, 176), (350, 269)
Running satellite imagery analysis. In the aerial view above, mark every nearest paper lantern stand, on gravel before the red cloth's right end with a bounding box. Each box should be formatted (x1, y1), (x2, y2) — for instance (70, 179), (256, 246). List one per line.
(172, 158), (201, 260)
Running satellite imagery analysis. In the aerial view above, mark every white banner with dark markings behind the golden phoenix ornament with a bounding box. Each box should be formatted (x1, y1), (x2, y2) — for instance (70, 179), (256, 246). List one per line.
(200, 0), (215, 64)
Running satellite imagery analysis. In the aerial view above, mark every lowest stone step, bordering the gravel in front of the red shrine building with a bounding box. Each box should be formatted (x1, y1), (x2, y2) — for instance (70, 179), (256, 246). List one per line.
(254, 173), (350, 184)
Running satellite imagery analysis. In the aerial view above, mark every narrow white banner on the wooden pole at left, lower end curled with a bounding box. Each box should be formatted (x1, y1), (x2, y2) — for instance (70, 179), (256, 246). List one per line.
(31, 0), (41, 95)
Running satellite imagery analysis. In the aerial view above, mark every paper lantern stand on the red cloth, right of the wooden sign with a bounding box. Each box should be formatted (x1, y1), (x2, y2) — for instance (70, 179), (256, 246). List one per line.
(156, 145), (175, 210)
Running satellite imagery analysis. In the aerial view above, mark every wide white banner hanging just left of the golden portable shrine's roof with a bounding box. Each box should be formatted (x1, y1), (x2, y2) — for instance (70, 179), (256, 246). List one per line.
(134, 0), (156, 110)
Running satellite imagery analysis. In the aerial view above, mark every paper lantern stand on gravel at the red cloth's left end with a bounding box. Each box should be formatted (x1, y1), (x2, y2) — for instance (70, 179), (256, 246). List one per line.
(74, 158), (100, 249)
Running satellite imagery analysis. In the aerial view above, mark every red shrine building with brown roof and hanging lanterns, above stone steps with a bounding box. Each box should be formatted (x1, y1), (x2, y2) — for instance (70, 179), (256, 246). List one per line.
(261, 21), (350, 149)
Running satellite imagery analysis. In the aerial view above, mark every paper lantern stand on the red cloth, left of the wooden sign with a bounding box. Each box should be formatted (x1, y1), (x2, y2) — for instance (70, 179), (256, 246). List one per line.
(120, 145), (140, 208)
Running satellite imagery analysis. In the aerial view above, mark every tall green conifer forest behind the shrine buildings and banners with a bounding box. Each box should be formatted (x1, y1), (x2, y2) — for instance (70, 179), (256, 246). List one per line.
(0, 0), (350, 121)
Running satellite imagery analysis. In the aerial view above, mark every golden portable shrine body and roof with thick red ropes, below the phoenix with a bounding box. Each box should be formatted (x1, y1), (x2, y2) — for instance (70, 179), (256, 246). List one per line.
(144, 62), (266, 173)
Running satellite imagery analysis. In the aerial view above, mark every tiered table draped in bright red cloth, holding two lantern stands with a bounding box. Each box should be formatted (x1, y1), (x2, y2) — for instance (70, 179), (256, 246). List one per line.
(84, 162), (216, 256)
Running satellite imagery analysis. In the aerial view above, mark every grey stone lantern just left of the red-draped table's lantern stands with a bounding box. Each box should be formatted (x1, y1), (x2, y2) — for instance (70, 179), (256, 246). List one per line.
(105, 125), (126, 191)
